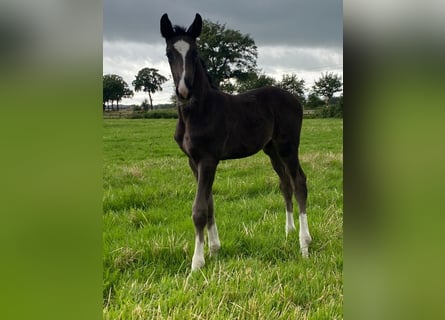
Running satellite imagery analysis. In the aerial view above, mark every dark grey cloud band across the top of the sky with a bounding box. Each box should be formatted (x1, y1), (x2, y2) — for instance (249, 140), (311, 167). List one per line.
(103, 0), (343, 47)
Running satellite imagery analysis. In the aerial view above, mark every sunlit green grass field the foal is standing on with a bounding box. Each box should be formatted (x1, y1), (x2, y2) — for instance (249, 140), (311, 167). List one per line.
(103, 119), (343, 319)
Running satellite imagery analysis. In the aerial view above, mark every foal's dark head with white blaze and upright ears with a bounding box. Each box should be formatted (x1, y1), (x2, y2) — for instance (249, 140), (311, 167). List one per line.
(161, 13), (202, 100)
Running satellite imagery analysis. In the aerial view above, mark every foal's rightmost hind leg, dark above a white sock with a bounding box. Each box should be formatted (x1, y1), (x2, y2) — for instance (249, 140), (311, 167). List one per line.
(283, 154), (312, 258)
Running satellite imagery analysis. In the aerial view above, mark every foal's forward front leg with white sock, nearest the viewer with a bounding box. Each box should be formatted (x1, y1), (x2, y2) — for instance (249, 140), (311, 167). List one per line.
(192, 159), (217, 271)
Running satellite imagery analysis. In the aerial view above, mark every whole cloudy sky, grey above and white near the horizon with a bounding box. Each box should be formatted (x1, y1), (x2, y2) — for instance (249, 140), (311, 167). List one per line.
(103, 0), (343, 104)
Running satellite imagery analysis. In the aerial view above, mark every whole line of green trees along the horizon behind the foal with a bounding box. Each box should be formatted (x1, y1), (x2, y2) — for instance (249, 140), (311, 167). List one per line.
(103, 20), (343, 110)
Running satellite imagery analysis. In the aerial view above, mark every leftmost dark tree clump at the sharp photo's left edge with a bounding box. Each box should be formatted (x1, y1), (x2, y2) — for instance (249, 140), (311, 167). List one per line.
(102, 74), (133, 110)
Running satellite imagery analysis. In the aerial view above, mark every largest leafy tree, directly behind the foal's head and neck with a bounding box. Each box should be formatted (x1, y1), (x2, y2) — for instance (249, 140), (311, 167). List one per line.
(198, 20), (258, 89)
